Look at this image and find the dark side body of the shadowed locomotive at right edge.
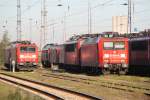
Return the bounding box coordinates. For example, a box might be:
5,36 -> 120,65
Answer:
130,39 -> 150,66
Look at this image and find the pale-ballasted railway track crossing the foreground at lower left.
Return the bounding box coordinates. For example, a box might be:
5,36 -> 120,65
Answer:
0,73 -> 101,100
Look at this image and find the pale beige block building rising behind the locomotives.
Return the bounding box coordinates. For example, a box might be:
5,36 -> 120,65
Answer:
112,16 -> 128,34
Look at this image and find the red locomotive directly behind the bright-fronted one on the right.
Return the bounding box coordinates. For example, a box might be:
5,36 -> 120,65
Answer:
61,34 -> 98,71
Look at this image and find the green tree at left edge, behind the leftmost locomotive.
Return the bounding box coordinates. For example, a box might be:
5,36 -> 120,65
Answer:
0,32 -> 10,64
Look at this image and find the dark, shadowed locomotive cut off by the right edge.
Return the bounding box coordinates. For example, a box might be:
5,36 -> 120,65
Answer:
129,30 -> 150,74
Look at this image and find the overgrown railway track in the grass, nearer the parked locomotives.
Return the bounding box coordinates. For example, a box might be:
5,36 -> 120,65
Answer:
42,73 -> 150,95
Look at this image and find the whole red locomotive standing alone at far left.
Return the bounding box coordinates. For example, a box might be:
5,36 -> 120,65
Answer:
4,41 -> 38,70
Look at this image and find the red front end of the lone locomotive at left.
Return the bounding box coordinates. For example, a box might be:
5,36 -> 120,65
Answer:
17,45 -> 38,70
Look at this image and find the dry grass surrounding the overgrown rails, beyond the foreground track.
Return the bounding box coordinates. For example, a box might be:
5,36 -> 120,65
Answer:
1,69 -> 150,100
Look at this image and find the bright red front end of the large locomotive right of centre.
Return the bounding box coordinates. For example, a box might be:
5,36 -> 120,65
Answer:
102,38 -> 128,74
